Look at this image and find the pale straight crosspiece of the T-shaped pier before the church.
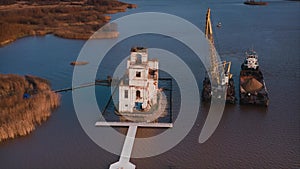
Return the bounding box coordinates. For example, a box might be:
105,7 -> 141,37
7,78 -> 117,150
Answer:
95,121 -> 173,128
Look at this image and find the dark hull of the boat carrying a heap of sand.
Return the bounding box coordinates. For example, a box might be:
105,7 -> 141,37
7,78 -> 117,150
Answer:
239,66 -> 269,106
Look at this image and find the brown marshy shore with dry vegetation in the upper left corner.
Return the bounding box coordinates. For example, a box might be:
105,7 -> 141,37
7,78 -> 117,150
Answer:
0,0 -> 137,47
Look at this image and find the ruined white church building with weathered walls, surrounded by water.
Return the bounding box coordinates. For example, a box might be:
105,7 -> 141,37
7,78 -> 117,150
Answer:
118,47 -> 159,113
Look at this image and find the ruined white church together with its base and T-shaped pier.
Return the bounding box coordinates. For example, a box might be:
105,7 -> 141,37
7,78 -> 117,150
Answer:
95,47 -> 169,169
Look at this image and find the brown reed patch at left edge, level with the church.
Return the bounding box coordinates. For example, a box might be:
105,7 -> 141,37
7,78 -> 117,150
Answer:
0,74 -> 60,142
